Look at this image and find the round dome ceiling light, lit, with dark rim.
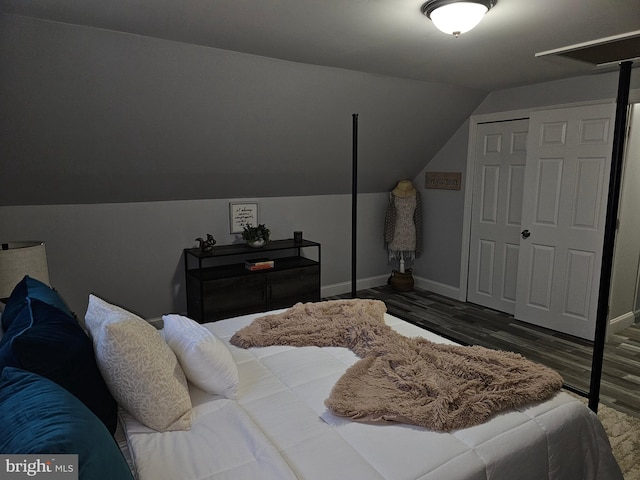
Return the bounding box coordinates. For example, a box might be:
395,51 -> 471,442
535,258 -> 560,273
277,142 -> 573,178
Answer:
420,0 -> 498,37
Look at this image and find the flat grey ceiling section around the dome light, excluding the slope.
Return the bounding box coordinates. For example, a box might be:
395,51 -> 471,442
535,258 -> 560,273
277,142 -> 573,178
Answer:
5,0 -> 640,91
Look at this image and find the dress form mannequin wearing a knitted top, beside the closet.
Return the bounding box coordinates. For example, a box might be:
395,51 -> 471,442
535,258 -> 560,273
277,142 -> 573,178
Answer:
384,180 -> 422,288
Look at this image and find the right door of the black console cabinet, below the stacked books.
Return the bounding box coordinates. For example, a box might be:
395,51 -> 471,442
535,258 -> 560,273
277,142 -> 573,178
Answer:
267,265 -> 320,310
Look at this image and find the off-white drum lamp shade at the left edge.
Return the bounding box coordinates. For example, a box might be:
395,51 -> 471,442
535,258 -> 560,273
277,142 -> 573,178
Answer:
0,242 -> 49,299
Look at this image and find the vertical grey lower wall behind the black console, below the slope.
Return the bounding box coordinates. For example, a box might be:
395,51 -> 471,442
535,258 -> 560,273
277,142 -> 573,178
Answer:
0,194 -> 390,317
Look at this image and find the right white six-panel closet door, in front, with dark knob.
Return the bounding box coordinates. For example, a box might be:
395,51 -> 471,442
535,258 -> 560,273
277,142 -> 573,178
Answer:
515,104 -> 615,340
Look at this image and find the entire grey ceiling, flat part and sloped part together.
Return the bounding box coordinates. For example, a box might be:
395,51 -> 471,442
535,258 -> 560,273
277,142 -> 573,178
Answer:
0,0 -> 640,205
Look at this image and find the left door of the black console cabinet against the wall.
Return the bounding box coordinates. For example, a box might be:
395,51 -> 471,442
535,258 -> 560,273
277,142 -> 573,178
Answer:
203,273 -> 266,322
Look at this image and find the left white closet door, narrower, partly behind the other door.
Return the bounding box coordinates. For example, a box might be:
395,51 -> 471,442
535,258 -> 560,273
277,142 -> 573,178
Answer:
467,119 -> 529,314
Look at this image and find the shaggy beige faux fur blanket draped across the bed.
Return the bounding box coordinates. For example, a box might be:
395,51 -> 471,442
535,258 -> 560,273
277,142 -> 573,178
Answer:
231,300 -> 562,431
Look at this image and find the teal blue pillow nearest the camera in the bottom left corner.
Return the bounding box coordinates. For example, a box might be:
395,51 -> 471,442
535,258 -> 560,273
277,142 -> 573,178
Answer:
0,367 -> 133,480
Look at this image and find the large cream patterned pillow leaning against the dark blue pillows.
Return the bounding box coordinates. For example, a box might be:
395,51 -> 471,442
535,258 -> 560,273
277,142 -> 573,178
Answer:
85,295 -> 191,432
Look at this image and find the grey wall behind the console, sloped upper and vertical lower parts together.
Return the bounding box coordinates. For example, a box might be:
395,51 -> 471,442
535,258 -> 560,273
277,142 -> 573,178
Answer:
0,15 -> 486,316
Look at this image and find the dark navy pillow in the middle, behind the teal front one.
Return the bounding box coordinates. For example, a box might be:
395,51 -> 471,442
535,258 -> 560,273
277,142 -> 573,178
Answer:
0,298 -> 118,433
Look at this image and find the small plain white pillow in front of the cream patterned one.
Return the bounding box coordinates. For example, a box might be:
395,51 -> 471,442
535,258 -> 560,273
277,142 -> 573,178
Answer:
162,315 -> 238,398
